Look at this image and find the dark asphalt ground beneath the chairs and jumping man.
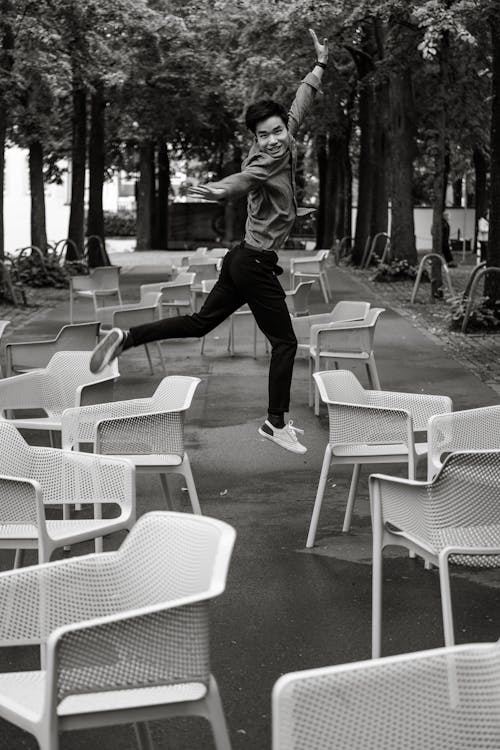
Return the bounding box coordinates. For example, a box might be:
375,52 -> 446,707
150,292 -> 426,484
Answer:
0,253 -> 500,750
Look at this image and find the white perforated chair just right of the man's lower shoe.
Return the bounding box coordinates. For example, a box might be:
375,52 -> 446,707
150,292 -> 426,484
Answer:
306,370 -> 452,547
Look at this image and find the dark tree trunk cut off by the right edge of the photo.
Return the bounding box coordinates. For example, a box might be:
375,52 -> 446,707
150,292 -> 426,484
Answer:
485,2 -> 500,304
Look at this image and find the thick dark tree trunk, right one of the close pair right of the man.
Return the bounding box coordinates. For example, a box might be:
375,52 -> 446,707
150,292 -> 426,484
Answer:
389,69 -> 417,265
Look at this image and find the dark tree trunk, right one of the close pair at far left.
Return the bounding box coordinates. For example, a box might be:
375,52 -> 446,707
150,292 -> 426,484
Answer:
87,82 -> 107,268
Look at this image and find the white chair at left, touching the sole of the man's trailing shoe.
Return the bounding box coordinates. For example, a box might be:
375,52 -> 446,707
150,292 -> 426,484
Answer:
5,321 -> 99,377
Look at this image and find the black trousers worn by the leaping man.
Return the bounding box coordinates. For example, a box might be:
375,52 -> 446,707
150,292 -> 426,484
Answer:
130,242 -> 297,413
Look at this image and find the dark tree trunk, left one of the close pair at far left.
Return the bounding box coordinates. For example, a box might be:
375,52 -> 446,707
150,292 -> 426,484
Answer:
67,85 -> 87,260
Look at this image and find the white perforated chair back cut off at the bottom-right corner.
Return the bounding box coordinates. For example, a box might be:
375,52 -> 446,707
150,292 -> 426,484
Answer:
272,643 -> 500,750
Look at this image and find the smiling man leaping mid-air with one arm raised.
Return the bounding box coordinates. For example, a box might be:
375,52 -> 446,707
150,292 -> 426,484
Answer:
90,29 -> 328,453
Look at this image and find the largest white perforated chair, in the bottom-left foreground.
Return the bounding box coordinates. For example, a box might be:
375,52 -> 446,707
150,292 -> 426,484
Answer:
0,512 -> 235,750
